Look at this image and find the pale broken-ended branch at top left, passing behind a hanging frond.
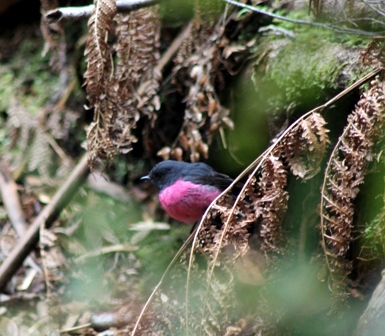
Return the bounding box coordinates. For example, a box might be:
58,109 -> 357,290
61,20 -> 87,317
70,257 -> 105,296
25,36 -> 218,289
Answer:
45,0 -> 159,23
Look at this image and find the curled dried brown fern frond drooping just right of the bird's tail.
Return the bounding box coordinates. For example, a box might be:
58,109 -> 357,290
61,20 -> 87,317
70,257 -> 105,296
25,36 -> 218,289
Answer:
197,113 -> 329,255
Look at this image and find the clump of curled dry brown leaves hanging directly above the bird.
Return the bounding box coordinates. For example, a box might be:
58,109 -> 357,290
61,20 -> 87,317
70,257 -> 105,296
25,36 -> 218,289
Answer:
158,0 -> 233,162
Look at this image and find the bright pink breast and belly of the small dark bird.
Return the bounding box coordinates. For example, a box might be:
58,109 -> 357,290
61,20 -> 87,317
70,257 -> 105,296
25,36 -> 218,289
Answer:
159,180 -> 221,224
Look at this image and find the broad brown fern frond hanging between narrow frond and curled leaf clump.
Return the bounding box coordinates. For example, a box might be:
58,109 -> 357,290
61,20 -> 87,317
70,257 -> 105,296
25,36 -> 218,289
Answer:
112,6 -> 161,153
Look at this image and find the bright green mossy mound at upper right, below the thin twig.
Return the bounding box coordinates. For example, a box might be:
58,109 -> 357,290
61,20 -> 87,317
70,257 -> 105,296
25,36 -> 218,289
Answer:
249,13 -> 370,111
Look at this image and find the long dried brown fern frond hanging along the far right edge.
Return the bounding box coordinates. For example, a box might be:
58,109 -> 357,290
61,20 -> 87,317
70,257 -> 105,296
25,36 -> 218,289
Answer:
321,79 -> 385,306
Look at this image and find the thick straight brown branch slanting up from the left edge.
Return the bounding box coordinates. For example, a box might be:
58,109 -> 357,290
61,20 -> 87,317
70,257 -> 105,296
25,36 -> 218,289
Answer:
0,155 -> 89,288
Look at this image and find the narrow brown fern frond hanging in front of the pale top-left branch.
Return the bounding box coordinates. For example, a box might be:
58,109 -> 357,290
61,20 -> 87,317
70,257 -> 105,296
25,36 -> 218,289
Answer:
84,0 -> 118,167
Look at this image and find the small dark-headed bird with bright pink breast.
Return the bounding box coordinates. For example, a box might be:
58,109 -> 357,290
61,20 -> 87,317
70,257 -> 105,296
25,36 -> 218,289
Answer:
141,160 -> 237,224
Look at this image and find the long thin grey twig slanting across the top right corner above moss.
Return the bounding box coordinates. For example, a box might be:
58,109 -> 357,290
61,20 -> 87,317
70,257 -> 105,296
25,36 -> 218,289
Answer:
224,0 -> 383,36
